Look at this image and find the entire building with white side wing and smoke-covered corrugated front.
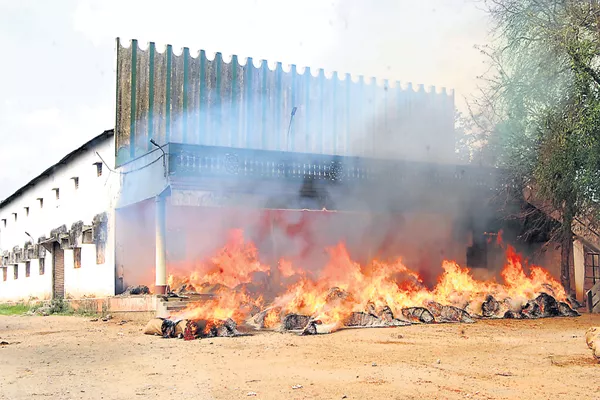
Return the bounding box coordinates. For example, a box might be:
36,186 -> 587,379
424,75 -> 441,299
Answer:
0,40 -> 596,306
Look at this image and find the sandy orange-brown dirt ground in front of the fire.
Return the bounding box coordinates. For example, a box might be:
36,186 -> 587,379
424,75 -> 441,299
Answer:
0,315 -> 600,399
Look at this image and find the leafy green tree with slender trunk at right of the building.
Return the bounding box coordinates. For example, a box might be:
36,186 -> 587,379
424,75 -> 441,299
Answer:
471,0 -> 600,290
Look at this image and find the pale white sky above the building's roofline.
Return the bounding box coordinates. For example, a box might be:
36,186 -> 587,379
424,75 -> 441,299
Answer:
0,0 -> 489,199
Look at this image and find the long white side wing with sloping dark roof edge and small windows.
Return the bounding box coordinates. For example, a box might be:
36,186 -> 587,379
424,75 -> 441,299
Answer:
0,130 -> 120,301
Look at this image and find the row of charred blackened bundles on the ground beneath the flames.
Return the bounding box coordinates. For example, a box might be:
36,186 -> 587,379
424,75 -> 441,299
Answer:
144,288 -> 580,340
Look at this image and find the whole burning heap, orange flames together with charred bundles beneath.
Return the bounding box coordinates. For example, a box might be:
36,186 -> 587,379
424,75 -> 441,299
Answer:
142,231 -> 579,340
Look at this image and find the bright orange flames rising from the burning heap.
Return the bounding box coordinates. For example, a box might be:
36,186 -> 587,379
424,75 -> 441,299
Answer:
169,230 -> 566,327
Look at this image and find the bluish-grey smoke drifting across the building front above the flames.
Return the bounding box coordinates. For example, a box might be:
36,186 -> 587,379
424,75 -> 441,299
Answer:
113,2 -> 556,286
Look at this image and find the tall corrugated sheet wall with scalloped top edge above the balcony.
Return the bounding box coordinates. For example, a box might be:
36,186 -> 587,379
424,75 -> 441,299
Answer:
115,39 -> 454,165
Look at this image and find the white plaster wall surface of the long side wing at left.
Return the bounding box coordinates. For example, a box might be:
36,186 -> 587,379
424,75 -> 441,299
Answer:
0,137 -> 121,300
